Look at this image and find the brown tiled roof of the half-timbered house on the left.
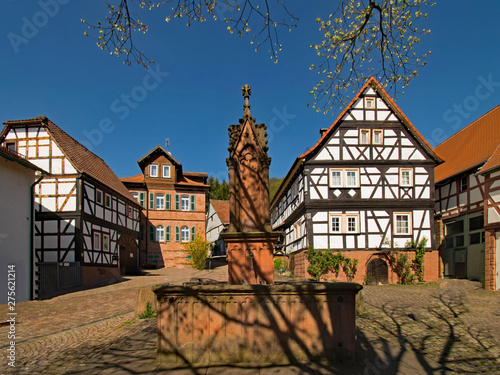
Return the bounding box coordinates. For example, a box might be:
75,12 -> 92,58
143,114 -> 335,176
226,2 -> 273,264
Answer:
0,116 -> 137,203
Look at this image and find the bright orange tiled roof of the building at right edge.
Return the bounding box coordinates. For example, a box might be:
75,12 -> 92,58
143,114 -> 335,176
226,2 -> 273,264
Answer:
435,105 -> 500,183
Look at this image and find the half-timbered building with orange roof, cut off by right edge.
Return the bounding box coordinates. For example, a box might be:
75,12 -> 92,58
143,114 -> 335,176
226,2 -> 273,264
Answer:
435,106 -> 500,290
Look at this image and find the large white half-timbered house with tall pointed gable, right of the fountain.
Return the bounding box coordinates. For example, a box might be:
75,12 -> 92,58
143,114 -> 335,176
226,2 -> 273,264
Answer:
271,78 -> 442,282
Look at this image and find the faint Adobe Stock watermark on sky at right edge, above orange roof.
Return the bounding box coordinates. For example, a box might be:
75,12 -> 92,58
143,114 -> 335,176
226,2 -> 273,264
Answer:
431,74 -> 500,144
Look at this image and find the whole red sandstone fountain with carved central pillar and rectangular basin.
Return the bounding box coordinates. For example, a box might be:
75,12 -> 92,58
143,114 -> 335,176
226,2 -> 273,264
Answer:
153,85 -> 362,368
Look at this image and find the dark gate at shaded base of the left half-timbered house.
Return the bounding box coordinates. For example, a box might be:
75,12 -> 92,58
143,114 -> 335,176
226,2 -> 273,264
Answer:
37,262 -> 80,294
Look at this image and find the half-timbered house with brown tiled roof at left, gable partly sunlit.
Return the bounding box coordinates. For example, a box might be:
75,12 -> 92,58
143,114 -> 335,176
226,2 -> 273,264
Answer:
0,116 -> 140,294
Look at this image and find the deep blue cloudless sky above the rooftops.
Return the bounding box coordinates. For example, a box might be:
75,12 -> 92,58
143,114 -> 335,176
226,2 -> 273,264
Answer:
0,0 -> 500,178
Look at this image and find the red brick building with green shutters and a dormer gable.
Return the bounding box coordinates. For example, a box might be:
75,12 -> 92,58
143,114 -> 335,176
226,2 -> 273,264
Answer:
121,146 -> 209,267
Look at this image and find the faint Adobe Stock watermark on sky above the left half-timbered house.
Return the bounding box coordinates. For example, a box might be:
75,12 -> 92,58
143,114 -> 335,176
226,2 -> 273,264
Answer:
80,64 -> 170,151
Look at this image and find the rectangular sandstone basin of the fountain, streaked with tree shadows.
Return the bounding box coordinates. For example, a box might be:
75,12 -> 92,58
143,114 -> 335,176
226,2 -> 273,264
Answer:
153,282 -> 362,368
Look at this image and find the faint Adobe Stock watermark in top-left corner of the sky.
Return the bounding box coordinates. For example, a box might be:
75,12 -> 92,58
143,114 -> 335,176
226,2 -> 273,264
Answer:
7,0 -> 70,53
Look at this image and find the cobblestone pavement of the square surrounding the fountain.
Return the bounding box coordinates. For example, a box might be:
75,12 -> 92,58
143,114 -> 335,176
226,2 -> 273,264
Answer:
0,266 -> 500,375
